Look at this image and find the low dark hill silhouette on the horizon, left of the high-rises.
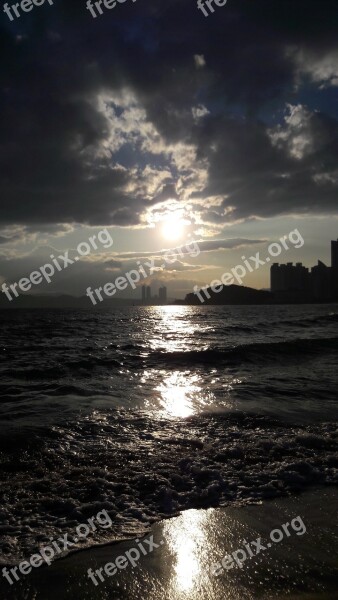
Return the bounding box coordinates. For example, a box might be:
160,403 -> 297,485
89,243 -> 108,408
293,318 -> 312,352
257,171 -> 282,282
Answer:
184,285 -> 273,305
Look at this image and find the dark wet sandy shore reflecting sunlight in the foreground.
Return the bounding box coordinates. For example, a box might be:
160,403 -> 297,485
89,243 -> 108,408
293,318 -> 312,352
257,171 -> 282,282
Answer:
0,488 -> 338,600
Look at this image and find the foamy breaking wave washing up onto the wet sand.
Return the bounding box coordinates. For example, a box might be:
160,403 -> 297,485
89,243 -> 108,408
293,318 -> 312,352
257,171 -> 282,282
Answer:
0,411 -> 338,564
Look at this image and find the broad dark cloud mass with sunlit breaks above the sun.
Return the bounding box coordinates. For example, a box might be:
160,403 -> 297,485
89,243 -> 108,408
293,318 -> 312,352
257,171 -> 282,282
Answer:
0,0 -> 338,237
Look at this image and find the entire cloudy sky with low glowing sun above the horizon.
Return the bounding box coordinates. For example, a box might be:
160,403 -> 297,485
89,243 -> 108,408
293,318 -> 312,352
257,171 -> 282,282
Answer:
0,0 -> 338,298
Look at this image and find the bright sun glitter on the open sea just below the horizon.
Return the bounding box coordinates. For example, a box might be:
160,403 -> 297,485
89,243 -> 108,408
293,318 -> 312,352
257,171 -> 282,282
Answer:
140,305 -> 238,418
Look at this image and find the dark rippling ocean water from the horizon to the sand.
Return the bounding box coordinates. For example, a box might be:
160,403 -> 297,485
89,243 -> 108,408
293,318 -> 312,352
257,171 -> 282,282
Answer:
0,305 -> 338,564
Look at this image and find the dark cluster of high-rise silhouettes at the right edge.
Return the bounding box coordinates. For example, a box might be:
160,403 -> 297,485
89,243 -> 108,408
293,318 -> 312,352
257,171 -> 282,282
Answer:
270,240 -> 338,302
